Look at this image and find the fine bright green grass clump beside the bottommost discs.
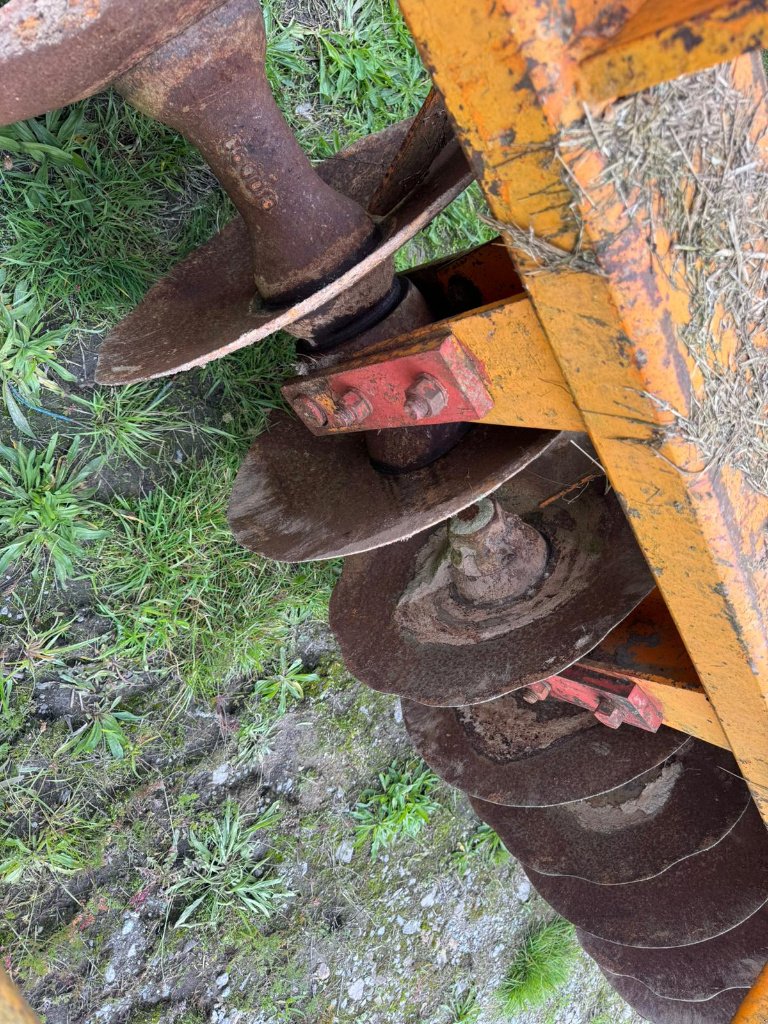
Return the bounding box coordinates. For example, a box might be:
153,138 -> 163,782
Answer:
498,918 -> 578,1015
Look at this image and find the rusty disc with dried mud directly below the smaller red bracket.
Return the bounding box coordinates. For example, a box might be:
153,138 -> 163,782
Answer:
402,693 -> 690,807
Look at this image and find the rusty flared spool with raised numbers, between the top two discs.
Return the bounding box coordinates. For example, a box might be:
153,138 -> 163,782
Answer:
115,0 -> 385,315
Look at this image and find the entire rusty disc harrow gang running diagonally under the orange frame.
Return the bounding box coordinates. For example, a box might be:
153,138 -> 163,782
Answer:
0,0 -> 768,1024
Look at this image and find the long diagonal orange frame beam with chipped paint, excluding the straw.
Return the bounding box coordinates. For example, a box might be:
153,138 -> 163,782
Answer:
400,0 -> 768,819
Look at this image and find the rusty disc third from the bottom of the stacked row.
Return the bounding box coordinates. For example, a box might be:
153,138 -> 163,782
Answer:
526,803 -> 768,948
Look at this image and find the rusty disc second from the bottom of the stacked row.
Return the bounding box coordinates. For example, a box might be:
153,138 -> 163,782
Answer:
579,904 -> 768,999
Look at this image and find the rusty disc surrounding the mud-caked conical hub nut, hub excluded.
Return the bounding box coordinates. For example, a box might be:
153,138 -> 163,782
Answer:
331,444 -> 653,707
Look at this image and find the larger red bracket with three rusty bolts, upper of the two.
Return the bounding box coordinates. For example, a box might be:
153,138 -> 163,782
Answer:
283,334 -> 494,434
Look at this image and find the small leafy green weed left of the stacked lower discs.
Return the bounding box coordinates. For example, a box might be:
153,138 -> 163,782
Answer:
351,759 -> 441,860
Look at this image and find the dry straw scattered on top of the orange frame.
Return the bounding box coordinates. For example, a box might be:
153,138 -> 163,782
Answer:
557,66 -> 768,495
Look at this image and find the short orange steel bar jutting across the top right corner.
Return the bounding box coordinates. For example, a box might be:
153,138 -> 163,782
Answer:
580,0 -> 768,100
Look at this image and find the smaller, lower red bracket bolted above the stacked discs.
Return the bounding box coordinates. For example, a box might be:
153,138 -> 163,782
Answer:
522,665 -> 664,732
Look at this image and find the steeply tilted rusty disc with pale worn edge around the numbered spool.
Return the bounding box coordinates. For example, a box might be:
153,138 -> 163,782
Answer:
95,129 -> 473,384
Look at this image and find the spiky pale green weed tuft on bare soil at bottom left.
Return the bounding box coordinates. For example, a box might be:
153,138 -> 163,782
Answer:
167,801 -> 292,928
